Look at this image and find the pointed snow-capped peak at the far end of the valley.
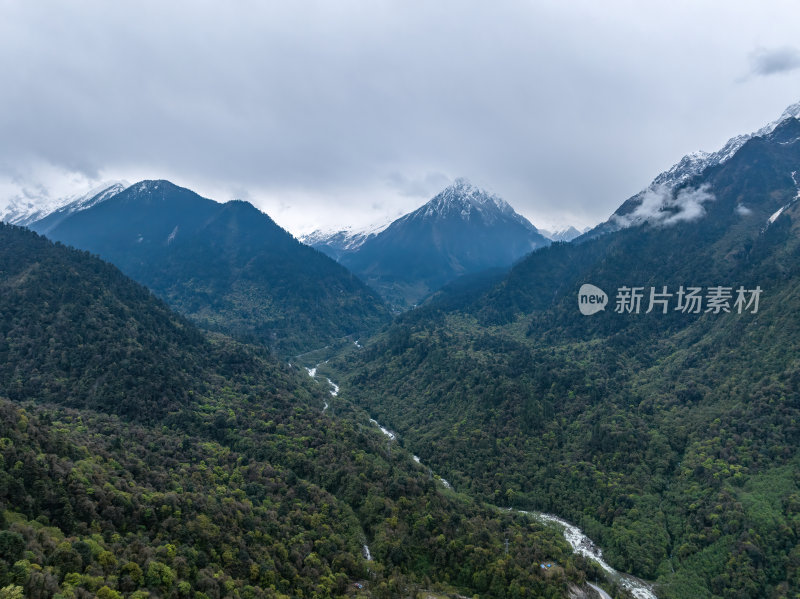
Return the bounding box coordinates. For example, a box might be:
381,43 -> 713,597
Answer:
316,179 -> 550,309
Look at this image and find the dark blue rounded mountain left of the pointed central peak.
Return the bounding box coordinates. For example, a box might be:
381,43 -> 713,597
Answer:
31,181 -> 388,354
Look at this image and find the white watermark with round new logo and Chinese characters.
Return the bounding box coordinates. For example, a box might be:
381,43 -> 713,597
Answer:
578,283 -> 762,316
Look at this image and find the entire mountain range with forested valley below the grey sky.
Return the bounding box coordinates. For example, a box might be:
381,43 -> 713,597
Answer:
0,104 -> 800,599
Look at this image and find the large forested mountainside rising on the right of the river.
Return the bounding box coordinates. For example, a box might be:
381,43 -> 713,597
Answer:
326,118 -> 800,598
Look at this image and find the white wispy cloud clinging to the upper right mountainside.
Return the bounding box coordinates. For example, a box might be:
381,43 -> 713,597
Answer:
613,185 -> 715,227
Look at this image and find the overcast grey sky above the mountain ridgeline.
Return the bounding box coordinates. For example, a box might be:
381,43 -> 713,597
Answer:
0,0 -> 800,234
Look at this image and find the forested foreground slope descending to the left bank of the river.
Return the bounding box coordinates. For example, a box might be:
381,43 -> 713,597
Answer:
0,225 -> 608,599
